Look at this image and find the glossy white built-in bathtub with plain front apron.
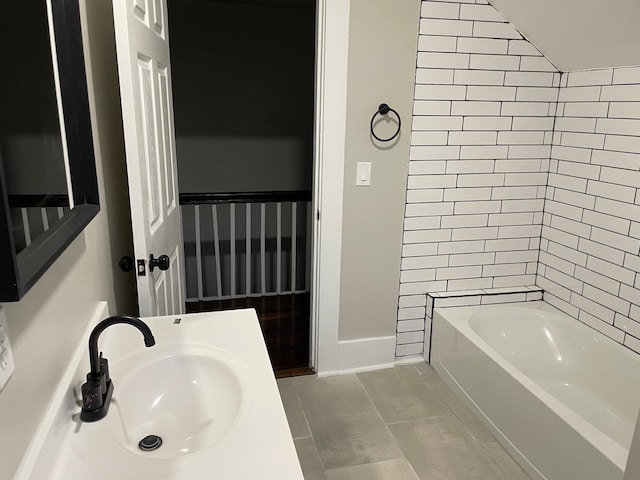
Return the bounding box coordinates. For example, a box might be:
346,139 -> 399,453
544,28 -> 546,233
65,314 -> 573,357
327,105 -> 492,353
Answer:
431,301 -> 640,480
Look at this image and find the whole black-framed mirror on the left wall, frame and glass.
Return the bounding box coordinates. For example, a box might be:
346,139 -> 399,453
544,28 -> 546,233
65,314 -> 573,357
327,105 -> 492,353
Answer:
0,0 -> 100,302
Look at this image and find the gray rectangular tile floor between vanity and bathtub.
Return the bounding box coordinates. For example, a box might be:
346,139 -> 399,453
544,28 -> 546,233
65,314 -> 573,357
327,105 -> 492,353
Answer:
278,363 -> 529,480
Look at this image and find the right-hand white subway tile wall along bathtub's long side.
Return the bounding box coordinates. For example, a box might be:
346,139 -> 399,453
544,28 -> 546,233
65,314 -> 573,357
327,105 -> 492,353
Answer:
537,67 -> 640,353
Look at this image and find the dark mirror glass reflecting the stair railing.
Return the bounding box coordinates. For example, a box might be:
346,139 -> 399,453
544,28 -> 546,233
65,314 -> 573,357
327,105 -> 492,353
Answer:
0,0 -> 69,253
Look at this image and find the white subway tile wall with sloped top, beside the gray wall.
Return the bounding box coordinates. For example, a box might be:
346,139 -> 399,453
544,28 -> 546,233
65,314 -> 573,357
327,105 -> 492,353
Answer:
396,0 -> 560,356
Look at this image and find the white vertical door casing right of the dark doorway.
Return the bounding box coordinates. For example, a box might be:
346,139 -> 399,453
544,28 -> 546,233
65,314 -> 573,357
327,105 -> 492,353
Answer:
310,0 -> 350,376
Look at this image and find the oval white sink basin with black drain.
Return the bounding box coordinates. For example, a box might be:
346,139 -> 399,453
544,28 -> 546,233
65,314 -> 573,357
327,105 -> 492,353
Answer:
108,347 -> 248,459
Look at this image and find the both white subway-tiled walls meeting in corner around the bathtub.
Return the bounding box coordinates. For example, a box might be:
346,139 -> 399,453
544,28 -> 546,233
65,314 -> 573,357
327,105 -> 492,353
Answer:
396,0 -> 640,357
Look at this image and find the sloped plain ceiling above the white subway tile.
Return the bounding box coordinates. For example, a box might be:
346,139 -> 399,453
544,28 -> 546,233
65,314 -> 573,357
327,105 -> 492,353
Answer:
489,0 -> 640,72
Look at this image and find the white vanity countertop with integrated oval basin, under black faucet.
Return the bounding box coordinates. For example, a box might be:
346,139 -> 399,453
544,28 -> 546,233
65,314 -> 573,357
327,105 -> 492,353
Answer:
18,310 -> 303,480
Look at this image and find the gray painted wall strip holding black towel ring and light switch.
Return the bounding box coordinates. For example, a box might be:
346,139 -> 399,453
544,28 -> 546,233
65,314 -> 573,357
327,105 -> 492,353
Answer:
339,0 -> 420,340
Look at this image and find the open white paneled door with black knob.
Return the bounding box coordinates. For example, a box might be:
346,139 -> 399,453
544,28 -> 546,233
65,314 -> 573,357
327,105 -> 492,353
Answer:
113,0 -> 185,316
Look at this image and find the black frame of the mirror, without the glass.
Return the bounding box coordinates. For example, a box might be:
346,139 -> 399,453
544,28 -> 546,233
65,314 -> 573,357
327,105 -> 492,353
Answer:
0,0 -> 100,302
